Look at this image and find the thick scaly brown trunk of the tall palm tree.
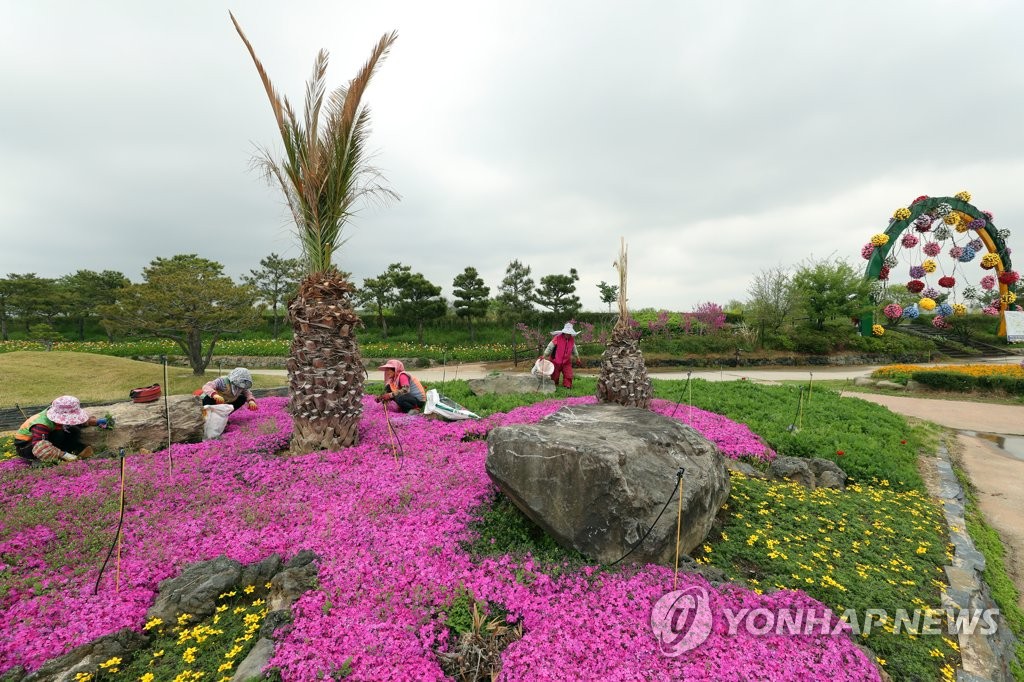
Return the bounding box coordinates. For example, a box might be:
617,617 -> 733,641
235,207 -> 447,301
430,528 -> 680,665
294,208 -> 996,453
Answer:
288,271 -> 366,455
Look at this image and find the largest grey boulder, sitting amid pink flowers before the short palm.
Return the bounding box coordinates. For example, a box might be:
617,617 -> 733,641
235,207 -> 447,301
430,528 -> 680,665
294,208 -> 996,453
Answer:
486,403 -> 729,563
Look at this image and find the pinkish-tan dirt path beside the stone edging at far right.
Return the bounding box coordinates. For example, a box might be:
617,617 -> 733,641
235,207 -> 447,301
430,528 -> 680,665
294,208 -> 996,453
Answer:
844,393 -> 1024,608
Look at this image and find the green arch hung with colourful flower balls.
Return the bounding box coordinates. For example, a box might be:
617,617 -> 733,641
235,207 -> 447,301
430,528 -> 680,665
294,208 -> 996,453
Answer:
859,191 -> 1020,336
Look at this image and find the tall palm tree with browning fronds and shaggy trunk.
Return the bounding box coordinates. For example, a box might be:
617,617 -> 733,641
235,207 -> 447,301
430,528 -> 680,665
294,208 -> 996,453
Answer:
231,14 -> 397,454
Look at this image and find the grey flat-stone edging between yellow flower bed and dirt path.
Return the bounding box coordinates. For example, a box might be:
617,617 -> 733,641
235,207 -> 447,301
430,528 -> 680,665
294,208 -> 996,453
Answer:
935,443 -> 1017,682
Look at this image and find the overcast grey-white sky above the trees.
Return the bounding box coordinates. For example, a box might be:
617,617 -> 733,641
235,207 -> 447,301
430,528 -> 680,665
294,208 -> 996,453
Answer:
0,0 -> 1024,310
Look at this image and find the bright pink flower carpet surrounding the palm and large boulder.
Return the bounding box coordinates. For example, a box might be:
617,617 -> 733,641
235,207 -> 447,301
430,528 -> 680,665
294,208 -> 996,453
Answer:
0,398 -> 879,681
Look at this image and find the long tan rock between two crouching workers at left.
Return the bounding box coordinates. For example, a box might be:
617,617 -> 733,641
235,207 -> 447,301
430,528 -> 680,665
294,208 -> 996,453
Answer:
82,395 -> 203,453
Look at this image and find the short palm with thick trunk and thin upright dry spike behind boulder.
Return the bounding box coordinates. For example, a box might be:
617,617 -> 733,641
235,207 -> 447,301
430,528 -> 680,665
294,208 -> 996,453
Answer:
597,239 -> 654,410
